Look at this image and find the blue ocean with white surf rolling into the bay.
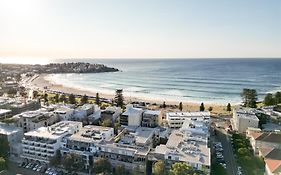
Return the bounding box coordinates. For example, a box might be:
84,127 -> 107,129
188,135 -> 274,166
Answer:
44,58 -> 281,104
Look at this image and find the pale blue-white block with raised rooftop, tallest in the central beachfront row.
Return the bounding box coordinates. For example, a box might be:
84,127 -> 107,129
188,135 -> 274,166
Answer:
120,104 -> 143,126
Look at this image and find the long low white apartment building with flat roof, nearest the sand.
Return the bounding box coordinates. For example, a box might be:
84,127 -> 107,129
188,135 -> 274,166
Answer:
166,111 -> 210,128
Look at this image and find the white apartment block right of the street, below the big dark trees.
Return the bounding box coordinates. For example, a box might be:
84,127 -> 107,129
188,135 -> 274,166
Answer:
232,107 -> 259,133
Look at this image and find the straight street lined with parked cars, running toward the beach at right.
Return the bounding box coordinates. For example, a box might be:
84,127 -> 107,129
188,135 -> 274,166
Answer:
216,129 -> 238,175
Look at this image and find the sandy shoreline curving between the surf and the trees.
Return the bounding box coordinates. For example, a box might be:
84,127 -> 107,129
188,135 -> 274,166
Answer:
26,74 -> 237,113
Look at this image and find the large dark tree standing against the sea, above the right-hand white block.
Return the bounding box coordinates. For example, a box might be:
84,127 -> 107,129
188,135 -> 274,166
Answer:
241,88 -> 258,108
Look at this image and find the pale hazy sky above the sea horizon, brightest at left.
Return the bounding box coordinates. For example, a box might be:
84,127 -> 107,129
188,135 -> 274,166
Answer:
0,0 -> 281,58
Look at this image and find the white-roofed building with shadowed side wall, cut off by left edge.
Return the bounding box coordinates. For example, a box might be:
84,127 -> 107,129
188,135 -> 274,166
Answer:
0,122 -> 23,159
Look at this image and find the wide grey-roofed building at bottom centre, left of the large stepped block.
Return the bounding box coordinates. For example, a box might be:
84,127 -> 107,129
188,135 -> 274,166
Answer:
97,127 -> 159,173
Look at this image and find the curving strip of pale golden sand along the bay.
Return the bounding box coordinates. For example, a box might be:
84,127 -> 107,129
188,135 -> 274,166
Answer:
26,74 -> 231,115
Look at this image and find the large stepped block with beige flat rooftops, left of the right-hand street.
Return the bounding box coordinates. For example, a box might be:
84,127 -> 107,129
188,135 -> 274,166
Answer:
149,116 -> 211,174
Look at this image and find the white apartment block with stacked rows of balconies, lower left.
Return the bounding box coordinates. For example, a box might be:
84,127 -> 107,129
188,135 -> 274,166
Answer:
21,121 -> 82,163
